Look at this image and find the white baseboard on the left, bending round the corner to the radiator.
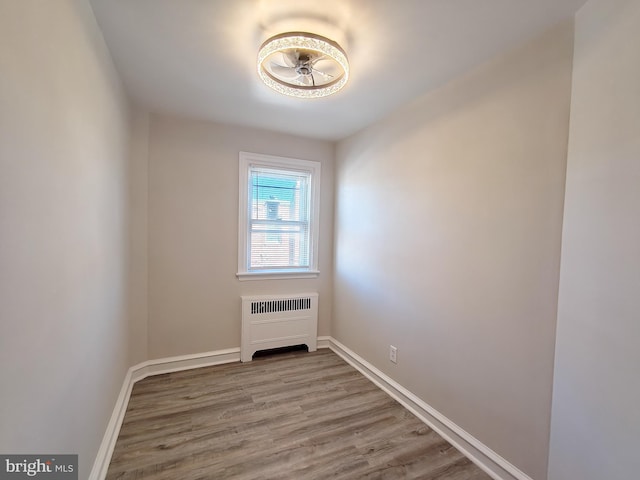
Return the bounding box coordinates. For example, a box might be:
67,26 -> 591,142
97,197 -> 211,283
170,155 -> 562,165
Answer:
89,348 -> 240,480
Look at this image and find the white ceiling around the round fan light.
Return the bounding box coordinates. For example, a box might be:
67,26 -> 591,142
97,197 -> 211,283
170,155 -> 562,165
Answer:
91,0 -> 585,140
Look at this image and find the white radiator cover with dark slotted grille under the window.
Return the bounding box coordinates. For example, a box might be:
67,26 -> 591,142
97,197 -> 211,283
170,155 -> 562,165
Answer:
240,293 -> 318,362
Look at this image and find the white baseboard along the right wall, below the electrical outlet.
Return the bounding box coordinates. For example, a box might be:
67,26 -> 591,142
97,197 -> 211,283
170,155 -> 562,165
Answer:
318,337 -> 532,480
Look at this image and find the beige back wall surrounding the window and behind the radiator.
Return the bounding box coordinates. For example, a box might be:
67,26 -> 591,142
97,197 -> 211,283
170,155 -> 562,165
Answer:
148,115 -> 334,358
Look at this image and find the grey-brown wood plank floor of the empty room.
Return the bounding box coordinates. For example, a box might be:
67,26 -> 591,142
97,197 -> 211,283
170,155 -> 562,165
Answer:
107,350 -> 490,480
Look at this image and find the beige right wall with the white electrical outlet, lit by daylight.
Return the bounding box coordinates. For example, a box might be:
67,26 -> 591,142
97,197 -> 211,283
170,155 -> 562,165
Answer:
332,25 -> 573,479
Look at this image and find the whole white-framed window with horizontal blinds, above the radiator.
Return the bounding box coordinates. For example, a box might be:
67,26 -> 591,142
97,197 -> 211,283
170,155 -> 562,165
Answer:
238,152 -> 320,280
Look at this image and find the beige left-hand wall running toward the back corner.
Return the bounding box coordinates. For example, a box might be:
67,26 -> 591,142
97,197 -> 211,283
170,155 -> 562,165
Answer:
0,0 -> 129,478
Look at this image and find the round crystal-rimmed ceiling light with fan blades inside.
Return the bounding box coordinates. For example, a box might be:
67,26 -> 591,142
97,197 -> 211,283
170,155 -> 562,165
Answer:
258,32 -> 349,98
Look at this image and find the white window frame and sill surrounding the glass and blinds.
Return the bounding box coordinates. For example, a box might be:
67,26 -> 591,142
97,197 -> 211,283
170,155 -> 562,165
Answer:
236,152 -> 321,280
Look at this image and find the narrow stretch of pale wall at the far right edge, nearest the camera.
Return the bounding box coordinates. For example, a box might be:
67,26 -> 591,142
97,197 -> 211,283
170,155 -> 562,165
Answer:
549,0 -> 640,480
